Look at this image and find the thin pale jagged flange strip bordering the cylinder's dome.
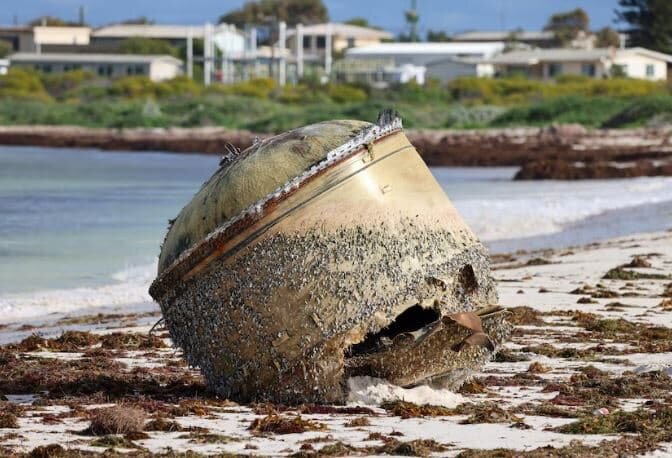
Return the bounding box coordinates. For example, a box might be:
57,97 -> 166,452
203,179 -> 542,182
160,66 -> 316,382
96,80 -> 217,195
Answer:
155,110 -> 403,281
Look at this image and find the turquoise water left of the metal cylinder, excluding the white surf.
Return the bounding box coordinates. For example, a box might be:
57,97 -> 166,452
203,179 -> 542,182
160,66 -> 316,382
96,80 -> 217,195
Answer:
0,147 -> 217,294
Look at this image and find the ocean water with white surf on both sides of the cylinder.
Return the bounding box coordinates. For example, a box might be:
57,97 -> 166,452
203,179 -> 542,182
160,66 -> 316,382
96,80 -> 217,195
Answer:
0,146 -> 672,321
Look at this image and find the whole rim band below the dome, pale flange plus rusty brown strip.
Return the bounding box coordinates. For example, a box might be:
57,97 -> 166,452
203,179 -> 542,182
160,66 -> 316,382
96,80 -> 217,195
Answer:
149,110 -> 404,300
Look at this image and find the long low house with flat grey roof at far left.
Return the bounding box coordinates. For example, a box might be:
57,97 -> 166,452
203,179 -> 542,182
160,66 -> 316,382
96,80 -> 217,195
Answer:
9,53 -> 182,81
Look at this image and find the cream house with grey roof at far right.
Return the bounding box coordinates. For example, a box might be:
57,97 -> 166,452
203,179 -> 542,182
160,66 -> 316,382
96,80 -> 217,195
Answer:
483,48 -> 672,81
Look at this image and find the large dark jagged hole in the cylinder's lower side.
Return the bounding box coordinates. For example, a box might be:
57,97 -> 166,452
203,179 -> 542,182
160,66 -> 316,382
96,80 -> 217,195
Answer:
345,305 -> 441,358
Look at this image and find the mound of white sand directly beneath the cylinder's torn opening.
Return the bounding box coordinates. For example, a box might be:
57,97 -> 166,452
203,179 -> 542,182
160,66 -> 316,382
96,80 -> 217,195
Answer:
348,376 -> 467,408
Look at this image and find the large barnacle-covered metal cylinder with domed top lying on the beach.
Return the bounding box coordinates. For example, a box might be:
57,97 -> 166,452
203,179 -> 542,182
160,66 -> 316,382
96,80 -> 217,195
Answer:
150,112 -> 509,403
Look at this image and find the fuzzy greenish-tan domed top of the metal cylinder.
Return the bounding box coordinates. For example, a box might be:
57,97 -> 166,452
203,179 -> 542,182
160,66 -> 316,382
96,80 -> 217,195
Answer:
159,120 -> 372,274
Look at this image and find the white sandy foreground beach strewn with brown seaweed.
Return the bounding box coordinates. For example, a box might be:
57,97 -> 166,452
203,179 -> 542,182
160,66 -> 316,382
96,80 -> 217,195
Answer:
0,231 -> 672,457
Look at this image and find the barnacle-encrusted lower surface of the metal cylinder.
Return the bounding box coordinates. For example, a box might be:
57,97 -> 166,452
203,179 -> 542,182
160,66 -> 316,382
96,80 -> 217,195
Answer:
163,220 -> 506,403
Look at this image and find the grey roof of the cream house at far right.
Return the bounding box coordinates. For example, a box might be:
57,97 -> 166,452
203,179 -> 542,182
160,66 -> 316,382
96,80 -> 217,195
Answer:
487,48 -> 615,65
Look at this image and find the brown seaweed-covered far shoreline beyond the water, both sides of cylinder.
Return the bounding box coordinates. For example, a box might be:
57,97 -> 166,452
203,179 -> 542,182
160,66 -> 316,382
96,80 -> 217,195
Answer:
0,125 -> 672,172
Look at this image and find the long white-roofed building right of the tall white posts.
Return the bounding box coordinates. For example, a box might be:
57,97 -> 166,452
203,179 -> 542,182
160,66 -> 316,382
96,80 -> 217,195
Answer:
345,42 -> 504,82
